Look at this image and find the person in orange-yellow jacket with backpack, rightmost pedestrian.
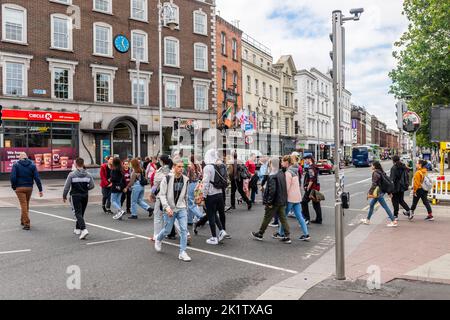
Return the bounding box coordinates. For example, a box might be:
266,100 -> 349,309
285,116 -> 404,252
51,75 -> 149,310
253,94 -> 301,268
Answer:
409,160 -> 434,221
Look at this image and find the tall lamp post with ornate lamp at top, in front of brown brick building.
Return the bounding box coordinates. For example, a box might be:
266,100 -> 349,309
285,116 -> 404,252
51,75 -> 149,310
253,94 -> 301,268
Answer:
158,0 -> 178,154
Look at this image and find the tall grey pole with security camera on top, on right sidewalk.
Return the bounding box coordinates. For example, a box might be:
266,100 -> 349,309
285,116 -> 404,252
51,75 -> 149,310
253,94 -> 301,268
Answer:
330,8 -> 364,280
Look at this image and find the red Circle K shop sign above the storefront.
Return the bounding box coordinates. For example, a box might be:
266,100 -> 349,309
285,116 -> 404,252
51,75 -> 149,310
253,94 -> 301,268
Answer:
2,110 -> 80,122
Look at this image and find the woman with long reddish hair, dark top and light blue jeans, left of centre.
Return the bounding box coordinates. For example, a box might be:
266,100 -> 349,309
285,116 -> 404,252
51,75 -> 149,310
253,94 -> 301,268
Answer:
123,159 -> 153,219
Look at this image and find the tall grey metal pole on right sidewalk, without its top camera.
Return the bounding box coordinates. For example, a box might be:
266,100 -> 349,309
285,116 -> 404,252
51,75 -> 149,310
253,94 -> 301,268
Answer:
333,10 -> 345,280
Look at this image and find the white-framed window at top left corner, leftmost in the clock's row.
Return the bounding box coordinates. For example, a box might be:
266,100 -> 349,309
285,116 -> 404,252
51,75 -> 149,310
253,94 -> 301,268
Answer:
2,3 -> 27,44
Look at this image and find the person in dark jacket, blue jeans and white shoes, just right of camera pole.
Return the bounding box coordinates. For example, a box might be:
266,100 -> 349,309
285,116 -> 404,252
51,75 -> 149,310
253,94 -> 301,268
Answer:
361,161 -> 398,227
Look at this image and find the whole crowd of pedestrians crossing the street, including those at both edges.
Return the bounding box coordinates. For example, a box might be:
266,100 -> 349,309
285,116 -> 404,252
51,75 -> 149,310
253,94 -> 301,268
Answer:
7,149 -> 434,261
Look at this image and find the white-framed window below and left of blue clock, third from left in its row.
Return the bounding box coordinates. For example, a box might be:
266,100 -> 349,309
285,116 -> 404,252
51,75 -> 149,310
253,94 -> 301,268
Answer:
91,64 -> 116,103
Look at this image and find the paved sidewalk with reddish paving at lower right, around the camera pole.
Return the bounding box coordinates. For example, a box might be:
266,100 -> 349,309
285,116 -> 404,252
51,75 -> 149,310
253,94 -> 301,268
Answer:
259,199 -> 450,300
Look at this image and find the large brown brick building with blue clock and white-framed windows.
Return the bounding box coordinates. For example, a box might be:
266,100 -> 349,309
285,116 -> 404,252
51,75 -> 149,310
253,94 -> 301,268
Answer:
0,0 -> 216,172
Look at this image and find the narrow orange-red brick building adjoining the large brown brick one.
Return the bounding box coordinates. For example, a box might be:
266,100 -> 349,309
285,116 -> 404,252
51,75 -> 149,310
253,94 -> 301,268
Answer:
216,16 -> 243,128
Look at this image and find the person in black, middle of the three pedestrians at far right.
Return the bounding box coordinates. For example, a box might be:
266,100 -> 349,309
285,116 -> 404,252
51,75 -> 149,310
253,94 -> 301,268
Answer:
391,156 -> 411,220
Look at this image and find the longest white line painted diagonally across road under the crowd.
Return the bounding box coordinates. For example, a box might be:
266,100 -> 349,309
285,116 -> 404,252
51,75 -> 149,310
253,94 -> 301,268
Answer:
30,210 -> 298,274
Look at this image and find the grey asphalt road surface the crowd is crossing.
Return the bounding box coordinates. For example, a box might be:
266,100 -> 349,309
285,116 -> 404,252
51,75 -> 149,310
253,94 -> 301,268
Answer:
0,162 -> 390,300
